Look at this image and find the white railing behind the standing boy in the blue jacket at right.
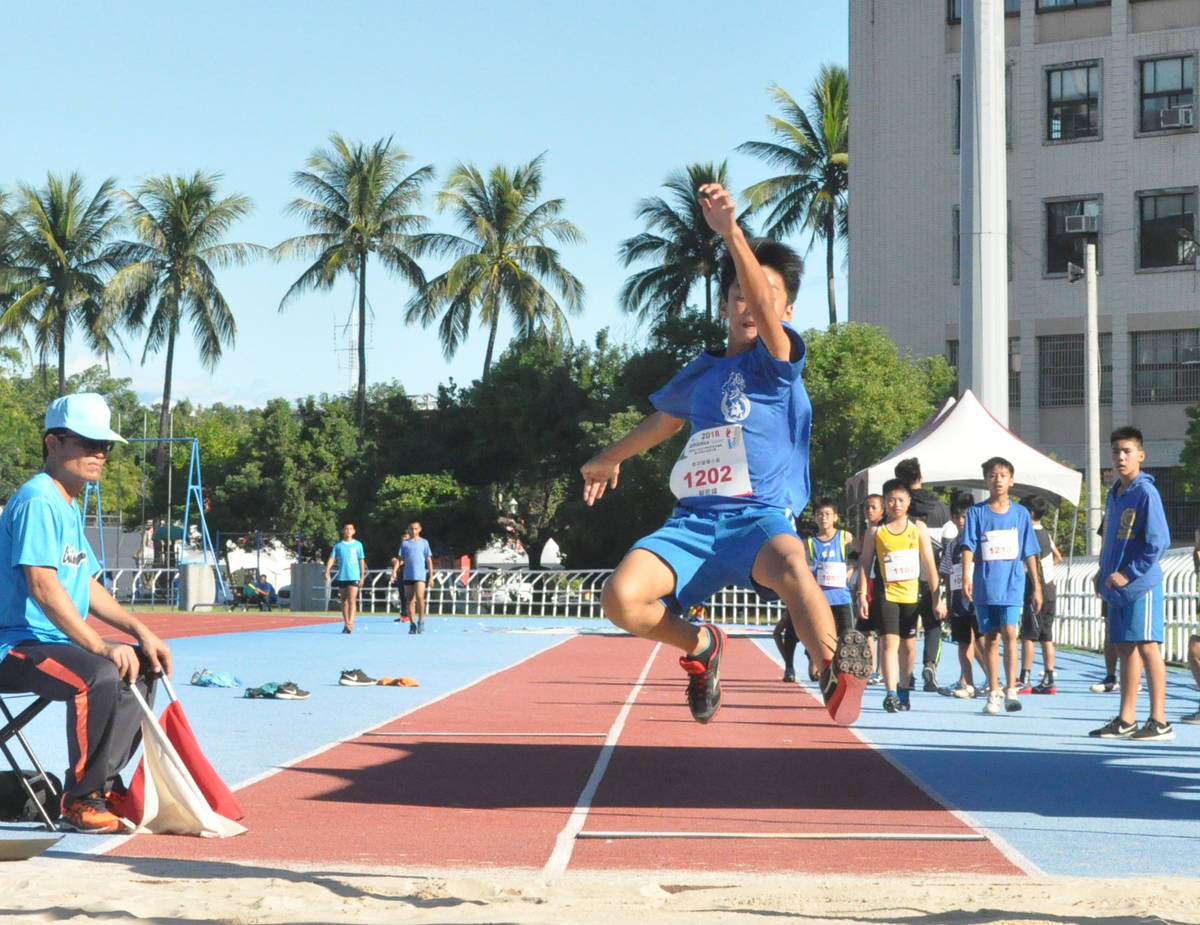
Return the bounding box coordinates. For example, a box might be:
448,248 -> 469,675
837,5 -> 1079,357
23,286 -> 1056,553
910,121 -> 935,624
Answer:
1054,547 -> 1200,663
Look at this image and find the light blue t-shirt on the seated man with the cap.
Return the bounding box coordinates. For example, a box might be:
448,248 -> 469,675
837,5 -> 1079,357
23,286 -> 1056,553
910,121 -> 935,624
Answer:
0,473 -> 100,659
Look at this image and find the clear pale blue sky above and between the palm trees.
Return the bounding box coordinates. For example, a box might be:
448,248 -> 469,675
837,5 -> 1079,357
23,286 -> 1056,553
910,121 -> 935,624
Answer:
0,0 -> 847,406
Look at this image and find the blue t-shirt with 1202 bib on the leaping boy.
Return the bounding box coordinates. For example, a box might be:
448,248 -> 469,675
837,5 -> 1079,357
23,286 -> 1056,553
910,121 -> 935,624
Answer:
650,324 -> 812,512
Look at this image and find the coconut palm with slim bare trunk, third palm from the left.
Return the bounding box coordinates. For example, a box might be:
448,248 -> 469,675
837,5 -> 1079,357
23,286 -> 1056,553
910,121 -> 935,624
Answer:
271,132 -> 433,427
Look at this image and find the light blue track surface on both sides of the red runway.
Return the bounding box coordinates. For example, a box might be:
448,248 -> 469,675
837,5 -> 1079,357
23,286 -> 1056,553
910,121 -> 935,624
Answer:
0,617 -> 1200,877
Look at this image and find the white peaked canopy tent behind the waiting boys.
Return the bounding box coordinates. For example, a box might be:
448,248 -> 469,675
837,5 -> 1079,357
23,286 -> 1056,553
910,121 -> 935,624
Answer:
846,389 -> 1084,505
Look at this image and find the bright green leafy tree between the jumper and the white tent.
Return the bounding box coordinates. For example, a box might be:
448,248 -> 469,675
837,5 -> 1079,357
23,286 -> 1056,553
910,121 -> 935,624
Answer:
804,324 -> 954,511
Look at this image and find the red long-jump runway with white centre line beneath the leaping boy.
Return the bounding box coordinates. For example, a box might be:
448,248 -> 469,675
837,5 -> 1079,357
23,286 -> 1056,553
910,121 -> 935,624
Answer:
113,636 -> 1022,876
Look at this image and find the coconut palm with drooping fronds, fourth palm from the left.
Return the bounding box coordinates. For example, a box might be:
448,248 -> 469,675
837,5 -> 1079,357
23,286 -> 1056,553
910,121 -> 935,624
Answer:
407,155 -> 583,379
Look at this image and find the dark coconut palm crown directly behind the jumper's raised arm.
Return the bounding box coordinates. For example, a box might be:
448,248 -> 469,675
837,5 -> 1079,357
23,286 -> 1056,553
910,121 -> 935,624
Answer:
617,161 -> 746,320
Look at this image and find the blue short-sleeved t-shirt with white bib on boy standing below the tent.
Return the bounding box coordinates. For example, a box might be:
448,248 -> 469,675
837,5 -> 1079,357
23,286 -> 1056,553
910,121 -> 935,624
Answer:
962,501 -> 1042,607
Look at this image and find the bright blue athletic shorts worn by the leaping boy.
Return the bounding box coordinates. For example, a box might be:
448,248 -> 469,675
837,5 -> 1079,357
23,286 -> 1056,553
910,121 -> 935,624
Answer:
632,507 -> 798,614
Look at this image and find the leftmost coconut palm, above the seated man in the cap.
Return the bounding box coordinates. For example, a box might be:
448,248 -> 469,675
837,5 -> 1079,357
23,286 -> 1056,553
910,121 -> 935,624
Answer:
0,173 -> 121,395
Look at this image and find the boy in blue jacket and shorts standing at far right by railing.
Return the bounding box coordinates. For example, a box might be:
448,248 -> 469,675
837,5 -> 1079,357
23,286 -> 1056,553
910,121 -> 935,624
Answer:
1090,427 -> 1175,741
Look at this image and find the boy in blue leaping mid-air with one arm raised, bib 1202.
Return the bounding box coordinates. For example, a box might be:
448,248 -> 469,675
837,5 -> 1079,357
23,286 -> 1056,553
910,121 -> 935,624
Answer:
581,184 -> 870,723
